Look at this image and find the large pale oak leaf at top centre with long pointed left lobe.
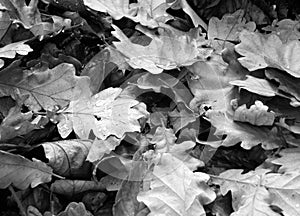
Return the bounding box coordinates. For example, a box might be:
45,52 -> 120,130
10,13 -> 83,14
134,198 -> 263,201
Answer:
112,25 -> 209,74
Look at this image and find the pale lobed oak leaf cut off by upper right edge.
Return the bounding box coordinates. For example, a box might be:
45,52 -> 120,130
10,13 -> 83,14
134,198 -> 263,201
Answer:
235,31 -> 300,78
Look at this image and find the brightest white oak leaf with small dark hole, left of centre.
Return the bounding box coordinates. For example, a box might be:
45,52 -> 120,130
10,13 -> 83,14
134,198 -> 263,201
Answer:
58,88 -> 148,140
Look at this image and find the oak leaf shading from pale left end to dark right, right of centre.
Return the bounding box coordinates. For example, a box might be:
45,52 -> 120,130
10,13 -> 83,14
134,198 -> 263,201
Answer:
207,111 -> 282,149
